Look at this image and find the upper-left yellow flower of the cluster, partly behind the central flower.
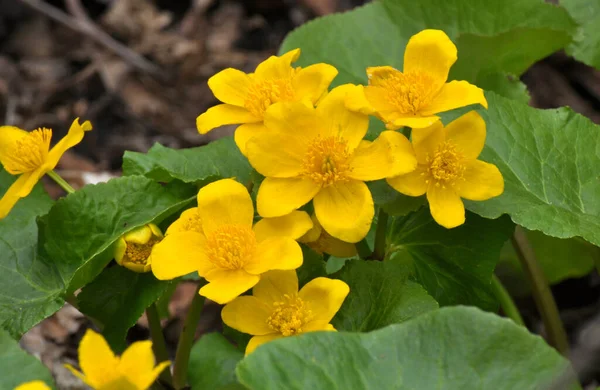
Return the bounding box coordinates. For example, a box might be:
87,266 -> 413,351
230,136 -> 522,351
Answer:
196,49 -> 337,155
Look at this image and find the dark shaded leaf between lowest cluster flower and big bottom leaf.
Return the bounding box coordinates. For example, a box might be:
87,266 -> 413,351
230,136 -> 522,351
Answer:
330,260 -> 438,332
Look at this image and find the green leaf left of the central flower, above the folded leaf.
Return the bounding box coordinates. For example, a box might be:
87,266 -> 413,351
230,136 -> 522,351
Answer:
123,137 -> 252,185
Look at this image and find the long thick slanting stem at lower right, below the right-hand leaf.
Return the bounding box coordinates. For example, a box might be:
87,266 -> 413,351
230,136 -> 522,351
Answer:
512,226 -> 569,356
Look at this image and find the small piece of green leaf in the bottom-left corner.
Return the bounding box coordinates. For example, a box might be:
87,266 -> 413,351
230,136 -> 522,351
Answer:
0,330 -> 54,390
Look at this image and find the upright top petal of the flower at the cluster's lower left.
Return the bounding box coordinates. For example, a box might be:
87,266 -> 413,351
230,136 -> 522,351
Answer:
198,179 -> 254,236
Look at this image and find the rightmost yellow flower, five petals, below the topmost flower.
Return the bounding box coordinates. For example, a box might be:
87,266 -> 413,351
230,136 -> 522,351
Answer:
387,111 -> 504,228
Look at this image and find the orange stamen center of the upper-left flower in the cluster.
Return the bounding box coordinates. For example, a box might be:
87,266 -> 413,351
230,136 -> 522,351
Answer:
244,78 -> 295,118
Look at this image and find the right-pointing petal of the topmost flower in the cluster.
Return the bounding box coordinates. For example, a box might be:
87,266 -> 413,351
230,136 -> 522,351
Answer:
420,81 -> 487,115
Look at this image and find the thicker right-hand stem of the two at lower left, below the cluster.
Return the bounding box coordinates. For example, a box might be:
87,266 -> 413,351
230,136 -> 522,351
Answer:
173,286 -> 204,390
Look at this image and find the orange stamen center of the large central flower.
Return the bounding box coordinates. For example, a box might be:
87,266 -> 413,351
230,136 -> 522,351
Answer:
302,137 -> 351,187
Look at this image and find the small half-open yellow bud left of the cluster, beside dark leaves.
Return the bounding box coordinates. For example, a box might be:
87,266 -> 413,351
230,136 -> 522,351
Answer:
115,223 -> 163,272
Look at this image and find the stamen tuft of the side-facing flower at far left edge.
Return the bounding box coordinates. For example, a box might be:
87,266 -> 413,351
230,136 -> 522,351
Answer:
3,128 -> 52,175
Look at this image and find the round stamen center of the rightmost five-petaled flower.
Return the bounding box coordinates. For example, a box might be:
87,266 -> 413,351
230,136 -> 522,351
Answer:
427,141 -> 466,186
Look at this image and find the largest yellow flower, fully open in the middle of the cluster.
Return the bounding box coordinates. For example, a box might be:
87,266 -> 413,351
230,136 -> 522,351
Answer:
247,85 -> 417,243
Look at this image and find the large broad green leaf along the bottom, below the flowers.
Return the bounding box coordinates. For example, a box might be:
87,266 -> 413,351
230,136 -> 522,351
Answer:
236,307 -> 577,390
